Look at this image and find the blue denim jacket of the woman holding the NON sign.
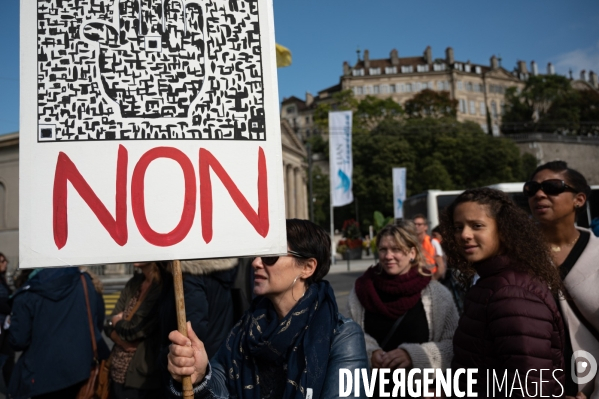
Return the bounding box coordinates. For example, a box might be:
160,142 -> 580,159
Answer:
170,314 -> 370,399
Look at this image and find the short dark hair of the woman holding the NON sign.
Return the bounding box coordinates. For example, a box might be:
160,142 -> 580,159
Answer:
287,219 -> 331,286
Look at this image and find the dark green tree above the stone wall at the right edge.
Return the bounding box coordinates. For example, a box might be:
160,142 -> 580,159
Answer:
502,75 -> 599,135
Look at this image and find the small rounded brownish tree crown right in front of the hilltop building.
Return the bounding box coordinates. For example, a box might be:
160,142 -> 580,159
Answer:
405,89 -> 458,118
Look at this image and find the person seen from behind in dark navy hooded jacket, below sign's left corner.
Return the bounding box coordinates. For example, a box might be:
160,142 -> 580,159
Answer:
8,267 -> 108,399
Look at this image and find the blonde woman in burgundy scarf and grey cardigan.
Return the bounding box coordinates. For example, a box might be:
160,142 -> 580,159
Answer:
348,222 -> 458,382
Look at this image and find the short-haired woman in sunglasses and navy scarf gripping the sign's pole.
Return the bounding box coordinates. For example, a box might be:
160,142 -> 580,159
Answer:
168,219 -> 368,399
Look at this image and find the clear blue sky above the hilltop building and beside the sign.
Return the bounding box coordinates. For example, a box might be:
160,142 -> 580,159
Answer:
0,0 -> 599,134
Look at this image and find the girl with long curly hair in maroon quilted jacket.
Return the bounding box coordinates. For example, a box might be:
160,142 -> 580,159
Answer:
441,188 -> 565,397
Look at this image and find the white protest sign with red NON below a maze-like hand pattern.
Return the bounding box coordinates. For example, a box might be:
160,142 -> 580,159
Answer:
19,0 -> 287,268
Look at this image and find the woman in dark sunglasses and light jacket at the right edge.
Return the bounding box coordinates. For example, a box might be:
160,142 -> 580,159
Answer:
524,161 -> 599,398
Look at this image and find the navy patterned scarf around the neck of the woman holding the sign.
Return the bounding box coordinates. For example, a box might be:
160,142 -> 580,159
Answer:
225,281 -> 338,399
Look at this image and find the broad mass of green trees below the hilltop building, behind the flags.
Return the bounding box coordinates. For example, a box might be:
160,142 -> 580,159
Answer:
313,89 -> 536,233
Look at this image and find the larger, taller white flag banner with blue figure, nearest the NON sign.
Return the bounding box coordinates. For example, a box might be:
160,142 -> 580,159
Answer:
329,111 -> 354,206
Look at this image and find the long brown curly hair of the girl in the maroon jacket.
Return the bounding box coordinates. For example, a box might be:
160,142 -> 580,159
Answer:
441,188 -> 562,294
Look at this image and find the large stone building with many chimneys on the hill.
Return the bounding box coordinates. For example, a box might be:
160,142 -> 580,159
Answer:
281,46 -> 599,140
